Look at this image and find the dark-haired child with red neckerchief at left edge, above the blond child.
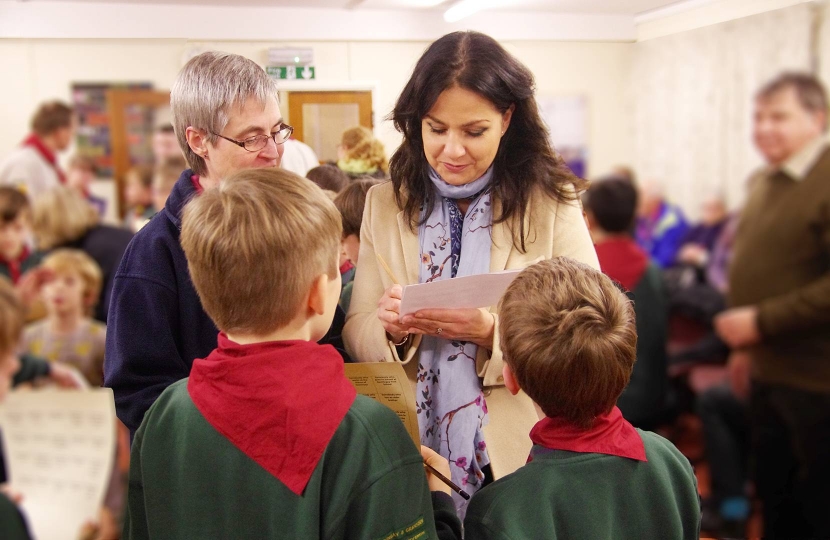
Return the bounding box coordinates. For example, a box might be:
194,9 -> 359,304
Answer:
0,186 -> 43,284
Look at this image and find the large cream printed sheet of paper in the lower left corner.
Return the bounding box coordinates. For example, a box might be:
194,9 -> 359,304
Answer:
0,388 -> 115,540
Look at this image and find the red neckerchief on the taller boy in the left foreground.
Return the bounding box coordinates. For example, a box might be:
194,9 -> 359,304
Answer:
187,333 -> 357,495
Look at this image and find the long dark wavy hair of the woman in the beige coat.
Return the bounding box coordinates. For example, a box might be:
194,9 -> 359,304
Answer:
389,32 -> 586,252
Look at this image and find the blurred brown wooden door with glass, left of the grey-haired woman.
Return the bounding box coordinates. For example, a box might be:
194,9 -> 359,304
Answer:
107,89 -> 170,219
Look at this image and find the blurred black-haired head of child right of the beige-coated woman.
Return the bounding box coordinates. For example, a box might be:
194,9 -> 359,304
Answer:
582,176 -> 637,234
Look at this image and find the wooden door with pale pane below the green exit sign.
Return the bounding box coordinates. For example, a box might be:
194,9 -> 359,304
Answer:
287,91 -> 373,162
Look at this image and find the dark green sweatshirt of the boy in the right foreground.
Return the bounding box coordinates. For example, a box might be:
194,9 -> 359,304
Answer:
464,430 -> 700,540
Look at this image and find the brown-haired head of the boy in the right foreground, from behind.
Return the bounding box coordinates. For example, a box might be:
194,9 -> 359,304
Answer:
499,257 -> 637,428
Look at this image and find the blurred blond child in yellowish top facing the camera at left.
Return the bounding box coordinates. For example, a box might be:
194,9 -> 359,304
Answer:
22,249 -> 107,387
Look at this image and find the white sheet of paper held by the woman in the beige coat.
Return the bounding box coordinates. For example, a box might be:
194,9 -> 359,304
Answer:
401,270 -> 521,317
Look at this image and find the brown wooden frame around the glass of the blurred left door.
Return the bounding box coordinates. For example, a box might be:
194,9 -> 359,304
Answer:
106,88 -> 170,219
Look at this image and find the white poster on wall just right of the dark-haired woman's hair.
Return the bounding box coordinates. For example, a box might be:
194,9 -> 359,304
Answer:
537,96 -> 588,178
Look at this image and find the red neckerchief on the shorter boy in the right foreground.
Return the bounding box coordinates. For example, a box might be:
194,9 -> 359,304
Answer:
530,407 -> 648,461
